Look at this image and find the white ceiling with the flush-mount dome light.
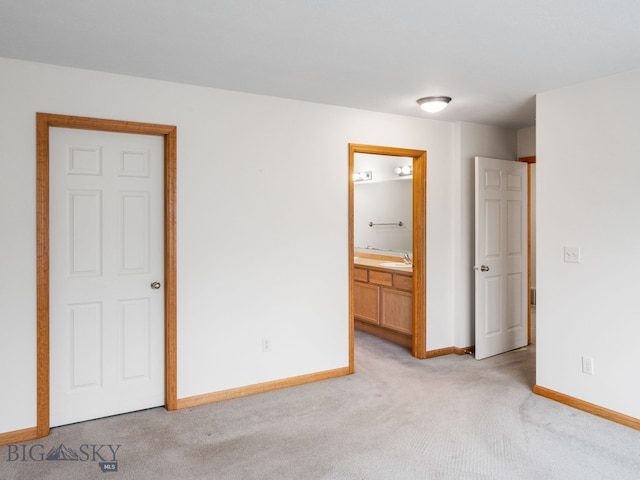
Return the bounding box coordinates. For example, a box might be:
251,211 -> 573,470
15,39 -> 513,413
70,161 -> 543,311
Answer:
0,0 -> 640,128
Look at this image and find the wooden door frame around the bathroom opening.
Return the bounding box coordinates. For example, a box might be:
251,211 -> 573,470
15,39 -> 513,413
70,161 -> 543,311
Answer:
349,143 -> 427,373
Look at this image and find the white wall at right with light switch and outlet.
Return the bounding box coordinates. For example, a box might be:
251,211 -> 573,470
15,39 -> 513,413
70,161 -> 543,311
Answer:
536,70 -> 640,418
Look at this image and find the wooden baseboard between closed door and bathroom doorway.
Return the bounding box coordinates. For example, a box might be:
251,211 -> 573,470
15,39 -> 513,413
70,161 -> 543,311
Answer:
177,367 -> 352,409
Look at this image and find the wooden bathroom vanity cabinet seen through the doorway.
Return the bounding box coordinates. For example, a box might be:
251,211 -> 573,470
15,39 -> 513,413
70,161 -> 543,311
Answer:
353,262 -> 413,347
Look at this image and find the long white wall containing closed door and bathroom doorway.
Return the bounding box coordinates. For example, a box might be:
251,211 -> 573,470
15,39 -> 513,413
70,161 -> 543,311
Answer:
0,59 -> 458,433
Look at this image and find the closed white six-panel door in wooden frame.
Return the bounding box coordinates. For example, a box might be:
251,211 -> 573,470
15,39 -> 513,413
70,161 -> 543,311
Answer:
49,128 -> 164,426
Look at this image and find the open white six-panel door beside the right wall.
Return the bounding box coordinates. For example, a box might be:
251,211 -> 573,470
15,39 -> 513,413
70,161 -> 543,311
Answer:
474,157 -> 528,360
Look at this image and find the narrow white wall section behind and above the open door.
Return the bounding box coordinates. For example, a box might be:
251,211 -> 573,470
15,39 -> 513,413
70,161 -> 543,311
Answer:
450,122 -> 517,347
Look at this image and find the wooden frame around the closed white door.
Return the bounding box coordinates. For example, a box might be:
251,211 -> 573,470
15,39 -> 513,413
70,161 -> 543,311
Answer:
36,113 -> 178,438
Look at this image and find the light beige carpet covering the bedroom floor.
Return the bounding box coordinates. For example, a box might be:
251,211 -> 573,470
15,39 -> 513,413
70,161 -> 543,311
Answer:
0,332 -> 640,480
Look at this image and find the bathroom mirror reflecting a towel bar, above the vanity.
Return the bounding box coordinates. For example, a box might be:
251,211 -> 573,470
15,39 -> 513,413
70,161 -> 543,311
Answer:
353,153 -> 413,256
